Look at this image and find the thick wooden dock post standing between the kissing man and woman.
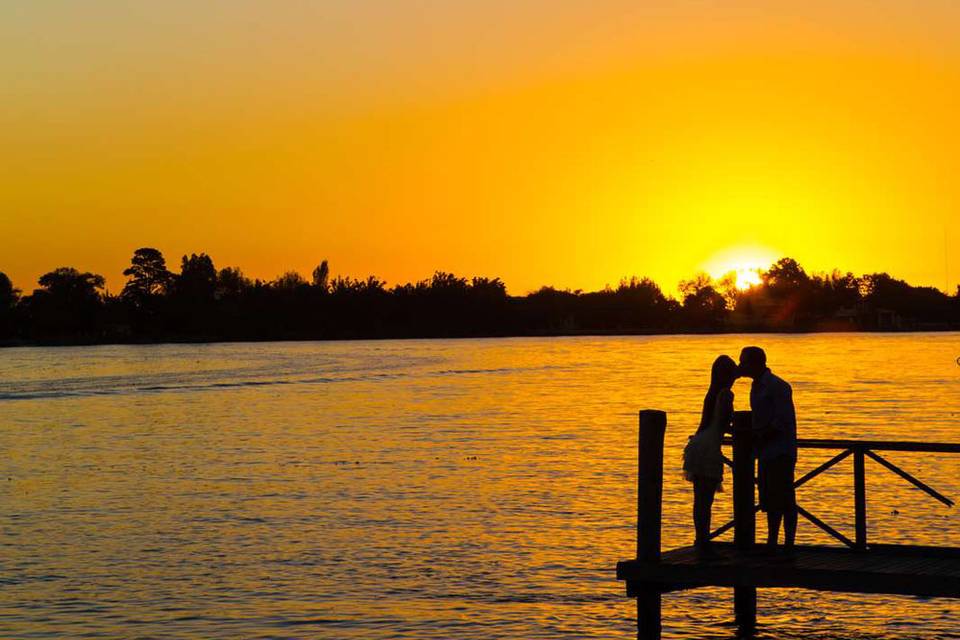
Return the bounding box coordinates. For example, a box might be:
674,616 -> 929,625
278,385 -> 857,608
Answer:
733,411 -> 757,636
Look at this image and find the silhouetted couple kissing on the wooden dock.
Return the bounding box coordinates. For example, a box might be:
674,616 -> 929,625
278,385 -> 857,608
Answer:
683,347 -> 797,557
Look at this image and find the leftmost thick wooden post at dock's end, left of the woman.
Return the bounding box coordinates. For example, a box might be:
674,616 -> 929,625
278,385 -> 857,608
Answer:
636,409 -> 667,640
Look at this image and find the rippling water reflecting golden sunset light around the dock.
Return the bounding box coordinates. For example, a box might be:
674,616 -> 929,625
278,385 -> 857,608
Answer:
0,333 -> 960,640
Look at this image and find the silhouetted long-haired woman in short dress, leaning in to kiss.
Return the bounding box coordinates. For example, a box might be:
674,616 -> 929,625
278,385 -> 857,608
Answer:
683,356 -> 737,555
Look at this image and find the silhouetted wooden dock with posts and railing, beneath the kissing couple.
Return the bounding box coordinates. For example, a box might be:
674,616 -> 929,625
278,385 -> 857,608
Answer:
617,411 -> 960,640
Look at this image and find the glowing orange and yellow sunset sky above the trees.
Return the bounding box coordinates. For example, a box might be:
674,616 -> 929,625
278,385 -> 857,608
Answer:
0,0 -> 960,294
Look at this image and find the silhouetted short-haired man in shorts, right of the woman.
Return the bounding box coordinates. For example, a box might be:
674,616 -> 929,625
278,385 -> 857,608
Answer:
740,347 -> 797,553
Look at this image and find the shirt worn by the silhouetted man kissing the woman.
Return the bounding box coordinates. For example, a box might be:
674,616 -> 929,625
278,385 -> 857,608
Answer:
750,369 -> 797,461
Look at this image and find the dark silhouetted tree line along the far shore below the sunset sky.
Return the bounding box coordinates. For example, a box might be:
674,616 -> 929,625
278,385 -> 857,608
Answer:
0,247 -> 960,344
